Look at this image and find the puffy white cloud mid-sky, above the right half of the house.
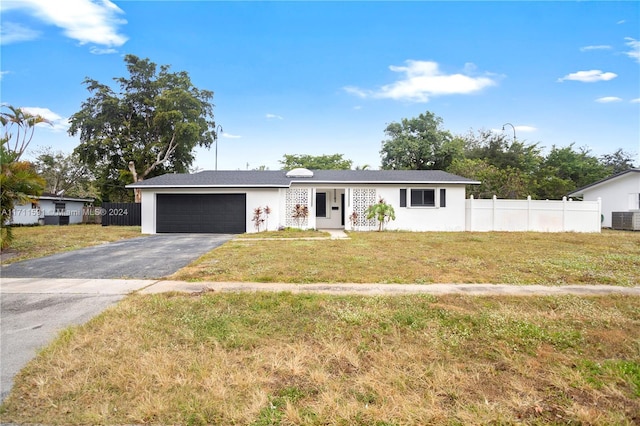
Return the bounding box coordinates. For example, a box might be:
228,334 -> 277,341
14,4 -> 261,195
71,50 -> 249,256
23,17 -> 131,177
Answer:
344,60 -> 496,102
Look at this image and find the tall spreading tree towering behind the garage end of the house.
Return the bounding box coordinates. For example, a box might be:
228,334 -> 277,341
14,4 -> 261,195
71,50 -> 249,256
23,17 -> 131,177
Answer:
69,55 -> 215,201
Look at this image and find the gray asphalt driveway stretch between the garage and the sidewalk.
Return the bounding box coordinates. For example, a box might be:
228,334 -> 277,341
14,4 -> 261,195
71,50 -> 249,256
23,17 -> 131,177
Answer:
2,234 -> 233,279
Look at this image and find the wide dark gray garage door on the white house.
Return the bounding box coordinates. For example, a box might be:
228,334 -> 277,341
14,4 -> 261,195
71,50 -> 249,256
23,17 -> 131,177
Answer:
156,194 -> 247,234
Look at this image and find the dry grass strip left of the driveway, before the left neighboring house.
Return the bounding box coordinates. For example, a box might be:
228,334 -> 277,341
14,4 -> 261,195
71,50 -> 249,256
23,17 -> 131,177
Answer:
2,225 -> 142,264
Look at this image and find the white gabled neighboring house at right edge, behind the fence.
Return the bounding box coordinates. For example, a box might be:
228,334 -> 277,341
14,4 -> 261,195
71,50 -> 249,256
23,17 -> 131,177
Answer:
569,169 -> 640,228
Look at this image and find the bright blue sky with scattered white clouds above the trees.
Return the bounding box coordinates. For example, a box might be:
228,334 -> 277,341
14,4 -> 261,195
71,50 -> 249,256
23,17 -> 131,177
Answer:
0,0 -> 640,170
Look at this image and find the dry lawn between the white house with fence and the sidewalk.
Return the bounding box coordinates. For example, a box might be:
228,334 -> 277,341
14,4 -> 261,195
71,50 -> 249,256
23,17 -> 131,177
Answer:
172,231 -> 640,286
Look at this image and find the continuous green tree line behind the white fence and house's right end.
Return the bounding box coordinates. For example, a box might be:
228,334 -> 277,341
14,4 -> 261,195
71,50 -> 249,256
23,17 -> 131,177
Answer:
380,111 -> 634,199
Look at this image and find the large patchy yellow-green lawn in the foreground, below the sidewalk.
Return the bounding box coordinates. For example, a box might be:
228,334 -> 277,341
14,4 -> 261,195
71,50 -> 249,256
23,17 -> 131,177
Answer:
0,293 -> 640,425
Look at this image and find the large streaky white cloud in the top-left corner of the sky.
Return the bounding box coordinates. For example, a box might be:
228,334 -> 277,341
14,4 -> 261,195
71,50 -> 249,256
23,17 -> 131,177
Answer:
2,0 -> 127,47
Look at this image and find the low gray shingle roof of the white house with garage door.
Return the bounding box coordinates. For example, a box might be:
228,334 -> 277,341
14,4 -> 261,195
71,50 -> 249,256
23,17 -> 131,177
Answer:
127,170 -> 480,188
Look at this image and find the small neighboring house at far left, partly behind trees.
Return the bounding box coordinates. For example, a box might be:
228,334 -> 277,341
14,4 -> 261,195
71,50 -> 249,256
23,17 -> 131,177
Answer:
11,193 -> 93,225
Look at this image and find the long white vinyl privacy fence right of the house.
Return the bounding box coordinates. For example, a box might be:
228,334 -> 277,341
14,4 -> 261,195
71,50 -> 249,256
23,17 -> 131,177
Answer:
465,196 -> 602,232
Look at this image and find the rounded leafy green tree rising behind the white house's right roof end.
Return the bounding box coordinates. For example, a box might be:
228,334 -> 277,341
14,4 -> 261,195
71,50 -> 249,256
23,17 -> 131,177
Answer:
380,111 -> 463,170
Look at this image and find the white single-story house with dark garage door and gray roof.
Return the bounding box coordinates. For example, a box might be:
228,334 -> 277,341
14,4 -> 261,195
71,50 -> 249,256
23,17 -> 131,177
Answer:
127,169 -> 479,234
